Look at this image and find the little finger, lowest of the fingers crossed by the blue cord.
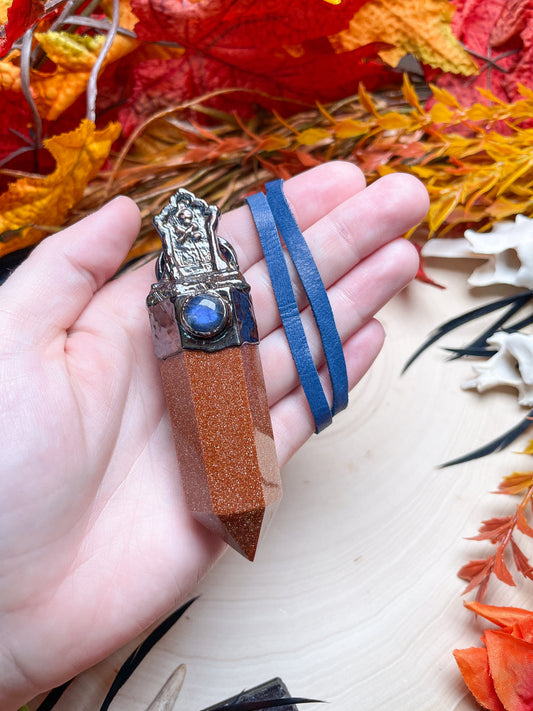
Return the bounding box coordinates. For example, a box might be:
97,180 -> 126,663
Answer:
270,320 -> 385,466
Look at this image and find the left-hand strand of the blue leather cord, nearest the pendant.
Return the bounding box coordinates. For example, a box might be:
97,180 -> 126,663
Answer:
246,193 -> 331,433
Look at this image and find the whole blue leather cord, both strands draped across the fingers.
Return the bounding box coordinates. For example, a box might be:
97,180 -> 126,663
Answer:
246,180 -> 348,433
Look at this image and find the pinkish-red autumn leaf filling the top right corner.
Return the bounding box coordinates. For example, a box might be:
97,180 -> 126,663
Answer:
427,0 -> 533,106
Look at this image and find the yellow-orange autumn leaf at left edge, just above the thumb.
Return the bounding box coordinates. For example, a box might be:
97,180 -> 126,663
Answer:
0,119 -> 120,256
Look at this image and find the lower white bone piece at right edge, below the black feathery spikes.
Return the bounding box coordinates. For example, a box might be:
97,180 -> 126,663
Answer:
462,331 -> 533,407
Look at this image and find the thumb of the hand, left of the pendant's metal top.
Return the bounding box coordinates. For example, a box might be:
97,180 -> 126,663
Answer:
0,197 -> 140,345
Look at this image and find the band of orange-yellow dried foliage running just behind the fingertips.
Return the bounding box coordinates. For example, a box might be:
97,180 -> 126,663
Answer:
79,77 -> 533,264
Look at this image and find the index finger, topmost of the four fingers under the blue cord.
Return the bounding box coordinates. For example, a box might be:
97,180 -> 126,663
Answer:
218,161 -> 365,271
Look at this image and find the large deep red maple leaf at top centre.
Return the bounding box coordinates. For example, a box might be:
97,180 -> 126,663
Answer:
120,0 -> 394,134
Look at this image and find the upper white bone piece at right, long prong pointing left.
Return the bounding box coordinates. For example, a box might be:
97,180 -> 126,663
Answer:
422,215 -> 533,289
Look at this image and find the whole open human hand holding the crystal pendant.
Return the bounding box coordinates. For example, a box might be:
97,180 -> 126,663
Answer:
0,163 -> 427,711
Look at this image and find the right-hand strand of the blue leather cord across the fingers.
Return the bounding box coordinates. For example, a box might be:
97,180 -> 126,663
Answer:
265,180 -> 348,415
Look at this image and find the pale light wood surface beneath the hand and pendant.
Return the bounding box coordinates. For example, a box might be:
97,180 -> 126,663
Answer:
30,260 -> 533,711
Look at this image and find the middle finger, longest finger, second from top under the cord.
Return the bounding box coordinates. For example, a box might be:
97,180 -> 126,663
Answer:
245,174 -> 428,337
